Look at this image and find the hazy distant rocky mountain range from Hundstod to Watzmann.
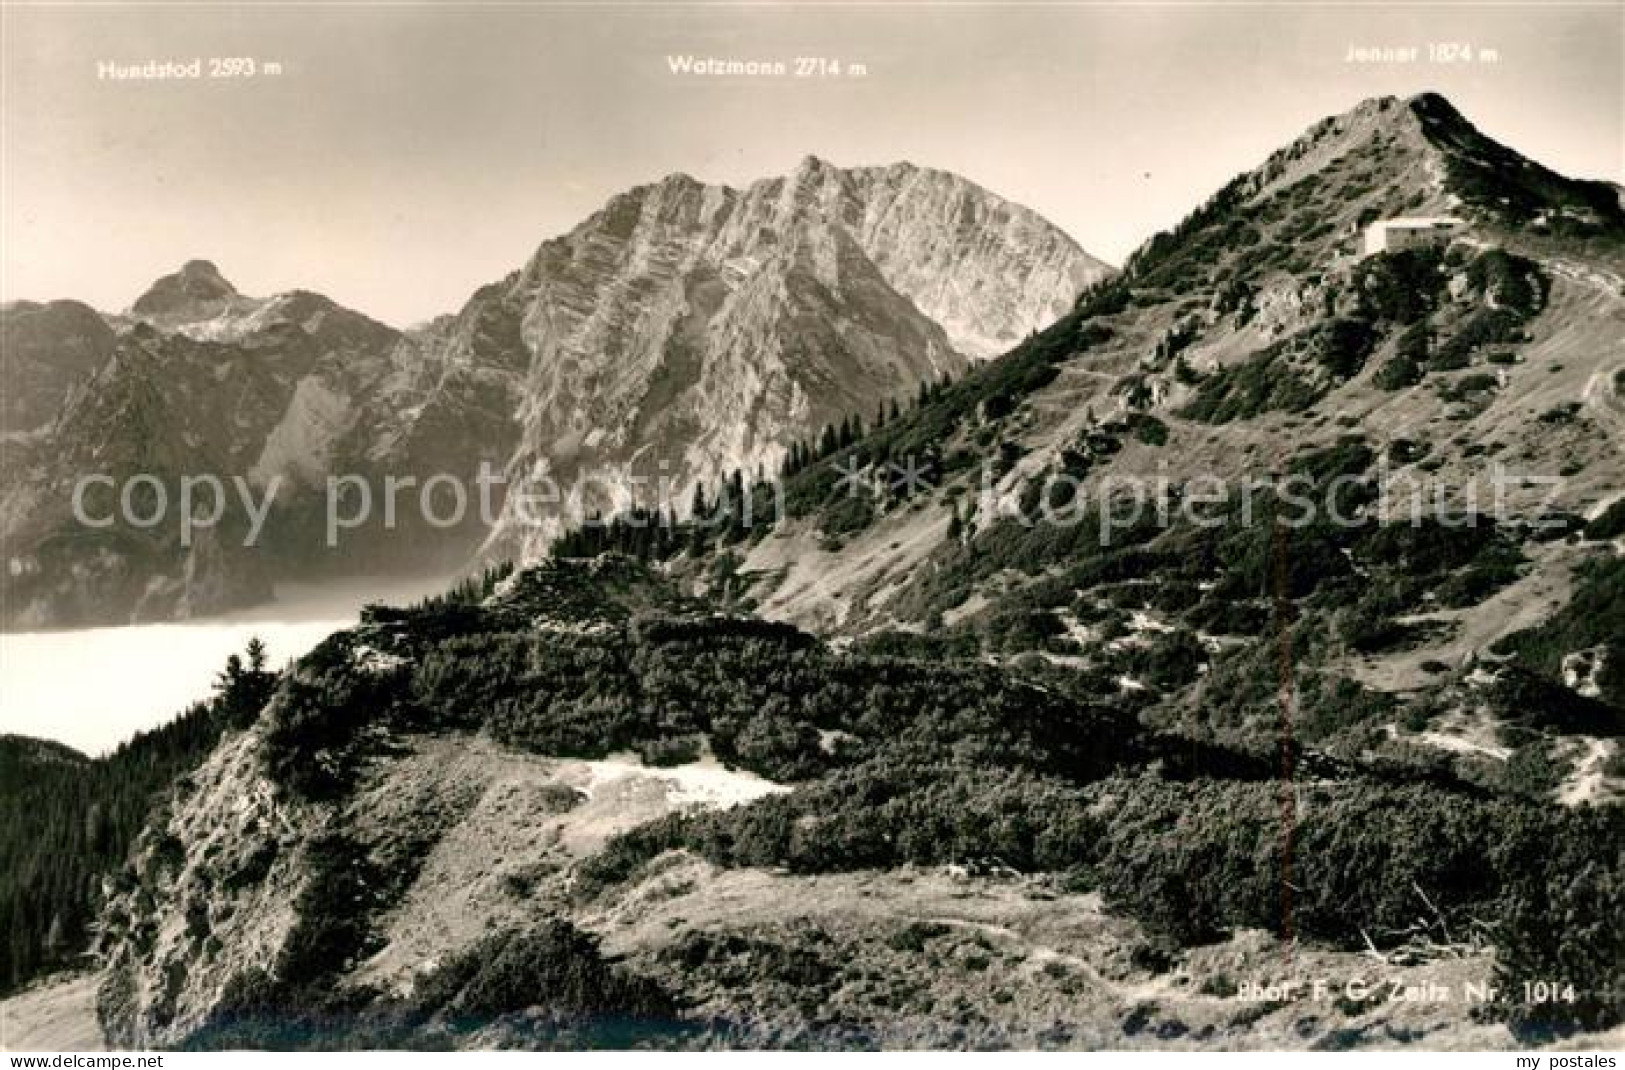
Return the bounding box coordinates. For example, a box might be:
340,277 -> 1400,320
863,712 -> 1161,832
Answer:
0,158 -> 1110,628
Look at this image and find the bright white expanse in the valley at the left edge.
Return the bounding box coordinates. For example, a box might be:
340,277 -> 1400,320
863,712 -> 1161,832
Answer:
0,577 -> 452,756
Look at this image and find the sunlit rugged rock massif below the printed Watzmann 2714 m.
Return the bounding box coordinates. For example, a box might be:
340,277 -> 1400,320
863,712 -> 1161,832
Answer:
476,158 -> 1108,558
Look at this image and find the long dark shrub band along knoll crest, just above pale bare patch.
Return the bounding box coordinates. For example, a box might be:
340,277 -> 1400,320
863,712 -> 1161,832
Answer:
265,565 -> 1157,797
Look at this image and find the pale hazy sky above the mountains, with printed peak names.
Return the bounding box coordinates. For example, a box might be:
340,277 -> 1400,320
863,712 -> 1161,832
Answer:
0,0 -> 1625,325
